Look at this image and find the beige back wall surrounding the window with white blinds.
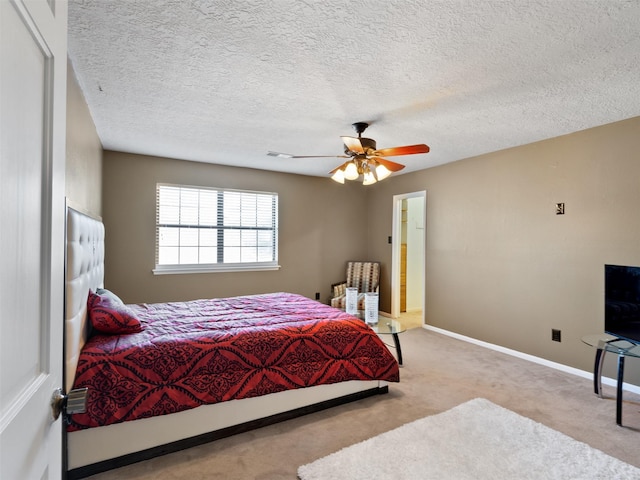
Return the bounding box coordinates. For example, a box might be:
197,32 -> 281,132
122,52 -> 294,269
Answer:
103,151 -> 367,303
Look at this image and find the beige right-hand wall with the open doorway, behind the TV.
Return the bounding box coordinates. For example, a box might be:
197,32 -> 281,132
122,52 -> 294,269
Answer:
368,117 -> 640,383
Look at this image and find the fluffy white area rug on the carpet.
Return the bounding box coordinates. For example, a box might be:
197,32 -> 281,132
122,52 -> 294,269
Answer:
298,398 -> 640,480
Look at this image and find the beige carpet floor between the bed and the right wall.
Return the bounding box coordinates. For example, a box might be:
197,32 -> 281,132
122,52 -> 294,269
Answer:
84,328 -> 640,480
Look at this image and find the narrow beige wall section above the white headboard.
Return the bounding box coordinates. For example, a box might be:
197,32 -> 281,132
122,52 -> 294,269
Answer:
65,62 -> 102,216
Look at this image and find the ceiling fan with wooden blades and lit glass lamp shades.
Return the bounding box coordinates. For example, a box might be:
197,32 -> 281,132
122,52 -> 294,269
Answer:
267,122 -> 429,185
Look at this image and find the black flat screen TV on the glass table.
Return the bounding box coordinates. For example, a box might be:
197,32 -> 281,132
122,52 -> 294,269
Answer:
604,265 -> 640,343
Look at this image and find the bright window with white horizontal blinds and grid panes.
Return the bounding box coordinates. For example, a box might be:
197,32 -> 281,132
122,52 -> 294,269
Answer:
154,184 -> 279,274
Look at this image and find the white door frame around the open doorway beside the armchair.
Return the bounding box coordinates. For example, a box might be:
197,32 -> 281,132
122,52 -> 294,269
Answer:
391,190 -> 427,318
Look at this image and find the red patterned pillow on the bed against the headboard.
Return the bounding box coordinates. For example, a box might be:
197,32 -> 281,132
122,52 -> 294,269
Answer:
87,292 -> 142,334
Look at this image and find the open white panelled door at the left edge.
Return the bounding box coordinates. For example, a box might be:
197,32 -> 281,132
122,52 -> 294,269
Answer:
0,0 -> 67,480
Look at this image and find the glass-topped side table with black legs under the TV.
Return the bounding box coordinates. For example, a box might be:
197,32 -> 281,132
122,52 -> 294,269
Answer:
582,333 -> 640,426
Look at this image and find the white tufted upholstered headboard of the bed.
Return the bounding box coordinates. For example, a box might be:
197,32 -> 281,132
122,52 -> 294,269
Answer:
64,207 -> 104,392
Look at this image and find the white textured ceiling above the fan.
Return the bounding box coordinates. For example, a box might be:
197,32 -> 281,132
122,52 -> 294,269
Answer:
69,0 -> 640,176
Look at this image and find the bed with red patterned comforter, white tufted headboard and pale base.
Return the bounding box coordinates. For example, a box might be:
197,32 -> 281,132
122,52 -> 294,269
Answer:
65,208 -> 399,478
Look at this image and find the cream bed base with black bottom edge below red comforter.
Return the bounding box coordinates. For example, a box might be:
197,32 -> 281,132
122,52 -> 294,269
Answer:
67,380 -> 389,480
